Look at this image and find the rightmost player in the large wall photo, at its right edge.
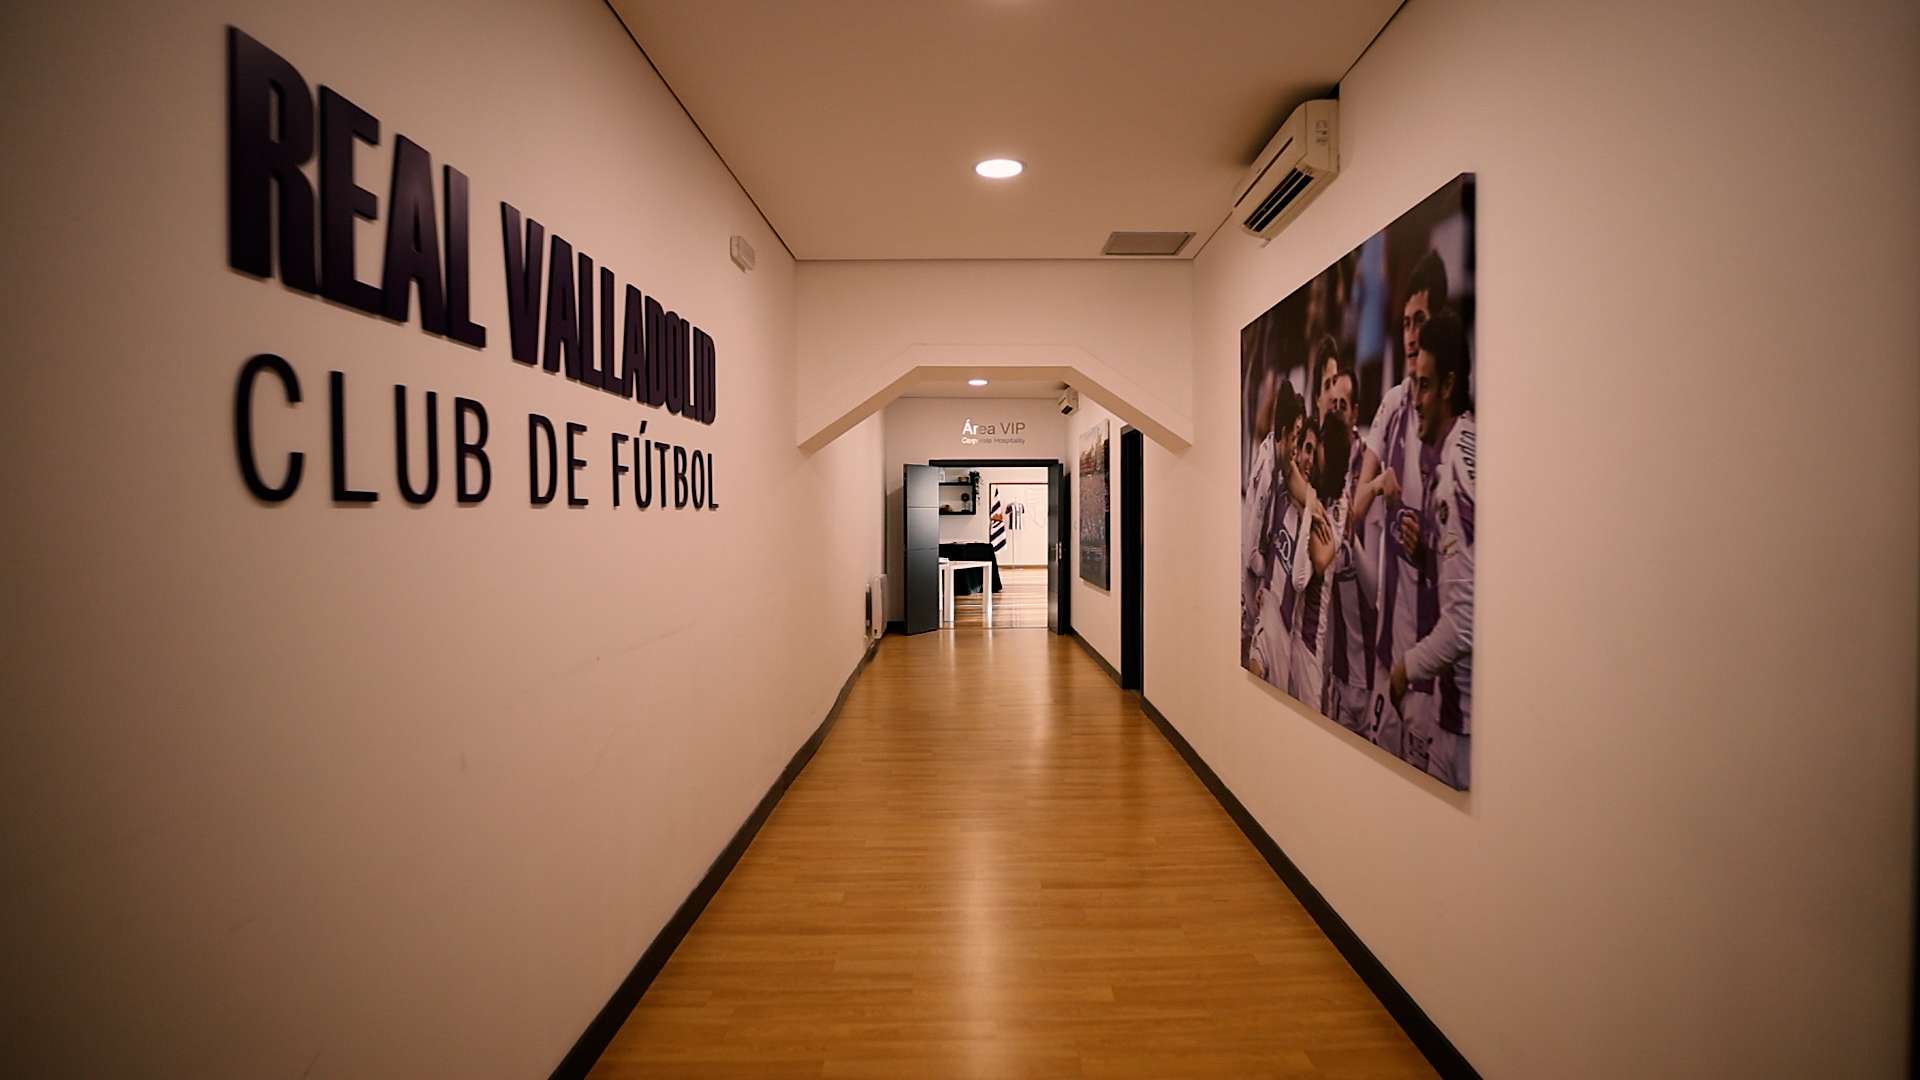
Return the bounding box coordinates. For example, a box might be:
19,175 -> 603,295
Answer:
1388,311 -> 1475,788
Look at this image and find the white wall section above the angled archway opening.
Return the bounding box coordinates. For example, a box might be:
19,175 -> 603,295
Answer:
795,259 -> 1192,442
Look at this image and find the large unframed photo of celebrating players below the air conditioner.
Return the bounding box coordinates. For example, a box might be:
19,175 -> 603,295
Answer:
1240,173 -> 1478,790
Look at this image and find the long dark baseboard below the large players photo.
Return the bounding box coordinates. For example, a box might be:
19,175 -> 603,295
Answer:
1136,691 -> 1480,1080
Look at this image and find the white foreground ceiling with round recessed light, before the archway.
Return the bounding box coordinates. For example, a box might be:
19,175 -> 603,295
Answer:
611,0 -> 1400,259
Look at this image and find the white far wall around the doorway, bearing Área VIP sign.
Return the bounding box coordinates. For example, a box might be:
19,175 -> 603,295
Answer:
879,398 -> 1068,619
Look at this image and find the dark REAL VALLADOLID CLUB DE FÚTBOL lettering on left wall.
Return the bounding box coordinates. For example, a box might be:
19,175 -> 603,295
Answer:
227,27 -> 720,509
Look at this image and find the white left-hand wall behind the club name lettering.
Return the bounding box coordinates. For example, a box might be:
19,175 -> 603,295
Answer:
0,0 -> 881,1078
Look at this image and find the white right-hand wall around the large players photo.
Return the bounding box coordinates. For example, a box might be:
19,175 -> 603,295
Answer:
1152,0 -> 1920,1078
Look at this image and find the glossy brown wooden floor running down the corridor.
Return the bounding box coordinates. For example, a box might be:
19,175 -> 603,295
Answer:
593,630 -> 1432,1080
